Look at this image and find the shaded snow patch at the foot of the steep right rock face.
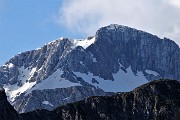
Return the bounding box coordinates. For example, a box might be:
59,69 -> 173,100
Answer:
74,67 -> 148,92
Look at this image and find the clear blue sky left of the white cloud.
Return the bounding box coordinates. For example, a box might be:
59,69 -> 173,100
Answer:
0,0 -> 83,65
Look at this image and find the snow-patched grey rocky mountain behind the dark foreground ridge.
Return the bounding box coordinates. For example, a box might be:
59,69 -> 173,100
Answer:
0,24 -> 180,113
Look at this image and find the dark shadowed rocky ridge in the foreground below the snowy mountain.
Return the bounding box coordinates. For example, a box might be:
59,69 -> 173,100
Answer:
0,79 -> 180,120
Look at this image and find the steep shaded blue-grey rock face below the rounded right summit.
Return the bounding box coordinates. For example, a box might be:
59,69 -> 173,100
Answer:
87,25 -> 180,80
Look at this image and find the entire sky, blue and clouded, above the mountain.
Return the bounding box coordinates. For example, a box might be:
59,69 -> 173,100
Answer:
0,0 -> 180,65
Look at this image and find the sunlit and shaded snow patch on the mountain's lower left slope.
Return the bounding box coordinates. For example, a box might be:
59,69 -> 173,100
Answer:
3,67 -> 82,102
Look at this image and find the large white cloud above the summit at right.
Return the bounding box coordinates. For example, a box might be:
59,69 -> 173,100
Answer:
58,0 -> 180,44
